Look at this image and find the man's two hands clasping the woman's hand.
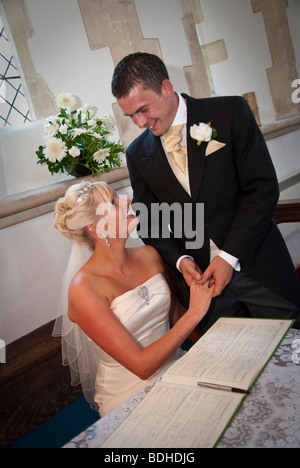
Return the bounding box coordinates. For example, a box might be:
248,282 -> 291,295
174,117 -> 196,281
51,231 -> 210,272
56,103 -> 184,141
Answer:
180,256 -> 234,297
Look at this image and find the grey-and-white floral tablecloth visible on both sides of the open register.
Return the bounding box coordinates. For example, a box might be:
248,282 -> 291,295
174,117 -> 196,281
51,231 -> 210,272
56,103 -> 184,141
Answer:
64,329 -> 300,448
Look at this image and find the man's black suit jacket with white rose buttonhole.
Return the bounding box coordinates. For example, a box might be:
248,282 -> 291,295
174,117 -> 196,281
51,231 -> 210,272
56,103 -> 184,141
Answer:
127,95 -> 300,305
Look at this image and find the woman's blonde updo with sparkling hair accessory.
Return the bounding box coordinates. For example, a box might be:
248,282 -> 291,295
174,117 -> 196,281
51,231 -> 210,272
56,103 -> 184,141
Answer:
54,182 -> 113,250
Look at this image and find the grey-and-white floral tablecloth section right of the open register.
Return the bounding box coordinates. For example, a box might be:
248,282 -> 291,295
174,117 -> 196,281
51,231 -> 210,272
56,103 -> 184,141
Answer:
219,330 -> 300,448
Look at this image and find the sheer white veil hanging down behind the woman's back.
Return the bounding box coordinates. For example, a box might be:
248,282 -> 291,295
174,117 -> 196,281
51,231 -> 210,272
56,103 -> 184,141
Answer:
53,242 -> 99,411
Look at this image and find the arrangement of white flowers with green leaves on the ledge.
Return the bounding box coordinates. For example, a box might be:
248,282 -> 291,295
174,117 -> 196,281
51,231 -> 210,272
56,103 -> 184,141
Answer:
36,93 -> 125,176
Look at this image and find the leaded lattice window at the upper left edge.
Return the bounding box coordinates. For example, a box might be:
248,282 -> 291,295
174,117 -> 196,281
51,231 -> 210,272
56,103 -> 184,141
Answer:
0,18 -> 31,127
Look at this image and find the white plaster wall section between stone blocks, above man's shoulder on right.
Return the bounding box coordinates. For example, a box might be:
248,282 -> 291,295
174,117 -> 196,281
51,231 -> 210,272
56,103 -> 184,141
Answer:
198,0 -> 275,124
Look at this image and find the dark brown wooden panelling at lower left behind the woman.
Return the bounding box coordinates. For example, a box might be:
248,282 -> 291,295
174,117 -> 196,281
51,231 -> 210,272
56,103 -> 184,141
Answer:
0,322 -> 82,448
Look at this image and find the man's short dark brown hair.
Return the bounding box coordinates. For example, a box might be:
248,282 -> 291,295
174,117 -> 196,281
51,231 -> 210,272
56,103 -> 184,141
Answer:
111,52 -> 169,99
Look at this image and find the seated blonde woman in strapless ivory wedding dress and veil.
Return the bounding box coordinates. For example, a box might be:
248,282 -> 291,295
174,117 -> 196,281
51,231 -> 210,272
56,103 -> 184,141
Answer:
54,182 -> 213,417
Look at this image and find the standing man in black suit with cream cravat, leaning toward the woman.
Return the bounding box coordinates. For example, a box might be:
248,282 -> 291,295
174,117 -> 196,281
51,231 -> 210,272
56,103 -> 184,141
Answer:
112,53 -> 300,331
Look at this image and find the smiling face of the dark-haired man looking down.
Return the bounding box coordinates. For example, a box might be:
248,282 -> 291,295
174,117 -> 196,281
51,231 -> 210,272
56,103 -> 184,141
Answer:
118,80 -> 178,136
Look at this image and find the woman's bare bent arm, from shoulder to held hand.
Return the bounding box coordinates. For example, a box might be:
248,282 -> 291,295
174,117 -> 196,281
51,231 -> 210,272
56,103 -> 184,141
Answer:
69,281 -> 213,380
